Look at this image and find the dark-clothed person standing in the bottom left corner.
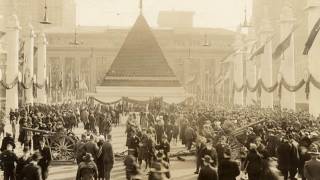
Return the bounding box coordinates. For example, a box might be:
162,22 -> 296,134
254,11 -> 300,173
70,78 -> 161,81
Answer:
0,143 -> 18,180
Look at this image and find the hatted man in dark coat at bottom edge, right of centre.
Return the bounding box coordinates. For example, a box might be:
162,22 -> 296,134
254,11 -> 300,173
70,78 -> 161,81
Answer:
198,155 -> 218,180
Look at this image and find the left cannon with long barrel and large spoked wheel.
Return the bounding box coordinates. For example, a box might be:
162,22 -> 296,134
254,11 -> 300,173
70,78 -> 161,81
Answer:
22,127 -> 79,162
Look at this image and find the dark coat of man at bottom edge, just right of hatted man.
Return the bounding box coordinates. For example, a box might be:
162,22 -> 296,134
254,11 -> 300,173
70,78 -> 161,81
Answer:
218,159 -> 240,180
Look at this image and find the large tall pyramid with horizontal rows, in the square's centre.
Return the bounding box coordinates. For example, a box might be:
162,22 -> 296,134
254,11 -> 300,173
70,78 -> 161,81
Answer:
101,15 -> 181,87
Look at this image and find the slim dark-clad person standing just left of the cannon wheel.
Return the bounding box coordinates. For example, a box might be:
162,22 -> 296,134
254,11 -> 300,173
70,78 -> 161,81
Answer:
38,139 -> 52,180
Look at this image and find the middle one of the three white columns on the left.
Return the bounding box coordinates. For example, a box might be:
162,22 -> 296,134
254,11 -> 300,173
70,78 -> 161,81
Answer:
24,25 -> 35,104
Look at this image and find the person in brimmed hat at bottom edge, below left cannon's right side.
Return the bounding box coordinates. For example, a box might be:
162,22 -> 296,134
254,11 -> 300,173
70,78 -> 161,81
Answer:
76,153 -> 98,180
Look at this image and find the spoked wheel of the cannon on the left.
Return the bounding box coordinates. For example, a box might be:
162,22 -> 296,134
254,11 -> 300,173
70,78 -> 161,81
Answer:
50,136 -> 74,160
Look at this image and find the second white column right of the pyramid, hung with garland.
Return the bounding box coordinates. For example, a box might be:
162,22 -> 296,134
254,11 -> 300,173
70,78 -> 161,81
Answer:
260,7 -> 273,108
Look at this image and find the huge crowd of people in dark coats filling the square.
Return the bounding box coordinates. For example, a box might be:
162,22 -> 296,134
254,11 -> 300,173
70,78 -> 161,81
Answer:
0,100 -> 320,180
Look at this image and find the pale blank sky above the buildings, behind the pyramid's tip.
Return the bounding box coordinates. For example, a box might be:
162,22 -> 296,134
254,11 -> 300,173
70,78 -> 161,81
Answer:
76,0 -> 252,29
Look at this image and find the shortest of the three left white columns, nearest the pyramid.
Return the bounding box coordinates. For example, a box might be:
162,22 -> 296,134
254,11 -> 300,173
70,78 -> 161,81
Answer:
37,32 -> 48,104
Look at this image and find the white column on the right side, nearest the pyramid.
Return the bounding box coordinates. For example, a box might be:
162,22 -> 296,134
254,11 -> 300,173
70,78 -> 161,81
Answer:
233,27 -> 245,106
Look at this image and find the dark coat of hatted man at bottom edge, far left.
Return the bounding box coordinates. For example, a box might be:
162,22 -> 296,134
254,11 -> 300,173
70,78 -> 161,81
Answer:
21,163 -> 42,180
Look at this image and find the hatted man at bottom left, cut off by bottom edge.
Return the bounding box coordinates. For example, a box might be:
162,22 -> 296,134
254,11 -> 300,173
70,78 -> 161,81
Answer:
21,152 -> 42,180
